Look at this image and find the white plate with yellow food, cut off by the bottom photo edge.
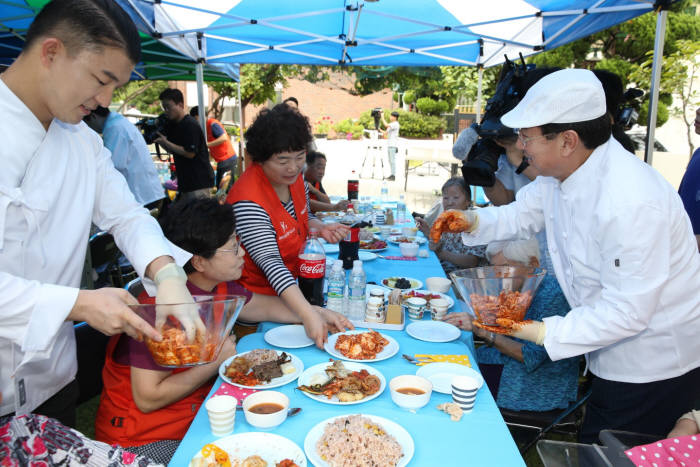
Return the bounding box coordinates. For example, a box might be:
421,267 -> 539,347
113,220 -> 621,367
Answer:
189,432 -> 307,467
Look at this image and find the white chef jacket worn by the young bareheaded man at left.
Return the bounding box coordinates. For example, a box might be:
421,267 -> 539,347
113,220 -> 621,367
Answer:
0,79 -> 173,415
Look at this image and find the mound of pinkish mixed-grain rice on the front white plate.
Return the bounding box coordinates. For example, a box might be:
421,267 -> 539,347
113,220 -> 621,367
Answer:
316,415 -> 403,467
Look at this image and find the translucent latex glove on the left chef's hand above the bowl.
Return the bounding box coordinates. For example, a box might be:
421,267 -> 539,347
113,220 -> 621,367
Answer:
153,263 -> 206,342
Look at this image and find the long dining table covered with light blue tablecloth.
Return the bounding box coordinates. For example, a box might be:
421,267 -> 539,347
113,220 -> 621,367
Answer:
170,232 -> 525,467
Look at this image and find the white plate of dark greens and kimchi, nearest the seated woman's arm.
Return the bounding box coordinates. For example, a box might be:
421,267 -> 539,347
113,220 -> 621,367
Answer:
219,349 -> 304,389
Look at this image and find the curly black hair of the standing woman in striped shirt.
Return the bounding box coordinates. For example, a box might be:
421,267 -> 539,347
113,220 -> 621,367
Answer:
244,104 -> 312,163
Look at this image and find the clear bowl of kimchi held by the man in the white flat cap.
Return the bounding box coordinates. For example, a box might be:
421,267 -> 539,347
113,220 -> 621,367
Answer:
450,266 -> 546,327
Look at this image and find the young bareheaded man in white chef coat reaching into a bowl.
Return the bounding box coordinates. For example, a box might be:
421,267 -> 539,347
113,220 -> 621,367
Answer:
0,0 -> 201,425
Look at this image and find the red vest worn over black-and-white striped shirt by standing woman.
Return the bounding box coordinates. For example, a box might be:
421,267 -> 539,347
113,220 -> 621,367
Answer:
226,162 -> 309,295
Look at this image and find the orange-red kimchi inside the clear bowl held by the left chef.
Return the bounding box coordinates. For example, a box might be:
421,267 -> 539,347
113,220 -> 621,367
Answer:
146,328 -> 216,366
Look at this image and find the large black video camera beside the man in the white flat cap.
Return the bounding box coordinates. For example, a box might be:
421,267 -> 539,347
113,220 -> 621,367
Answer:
453,55 -> 550,187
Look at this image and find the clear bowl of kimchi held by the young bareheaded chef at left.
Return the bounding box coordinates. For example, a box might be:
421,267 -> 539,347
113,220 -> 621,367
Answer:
129,295 -> 246,368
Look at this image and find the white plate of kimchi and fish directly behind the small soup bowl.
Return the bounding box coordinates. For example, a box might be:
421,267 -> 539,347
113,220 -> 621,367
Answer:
297,359 -> 386,405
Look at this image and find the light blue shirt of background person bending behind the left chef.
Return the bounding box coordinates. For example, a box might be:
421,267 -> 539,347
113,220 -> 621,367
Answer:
102,112 -> 165,205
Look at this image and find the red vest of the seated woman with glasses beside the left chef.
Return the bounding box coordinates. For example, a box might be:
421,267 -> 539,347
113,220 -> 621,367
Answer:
95,282 -> 228,446
